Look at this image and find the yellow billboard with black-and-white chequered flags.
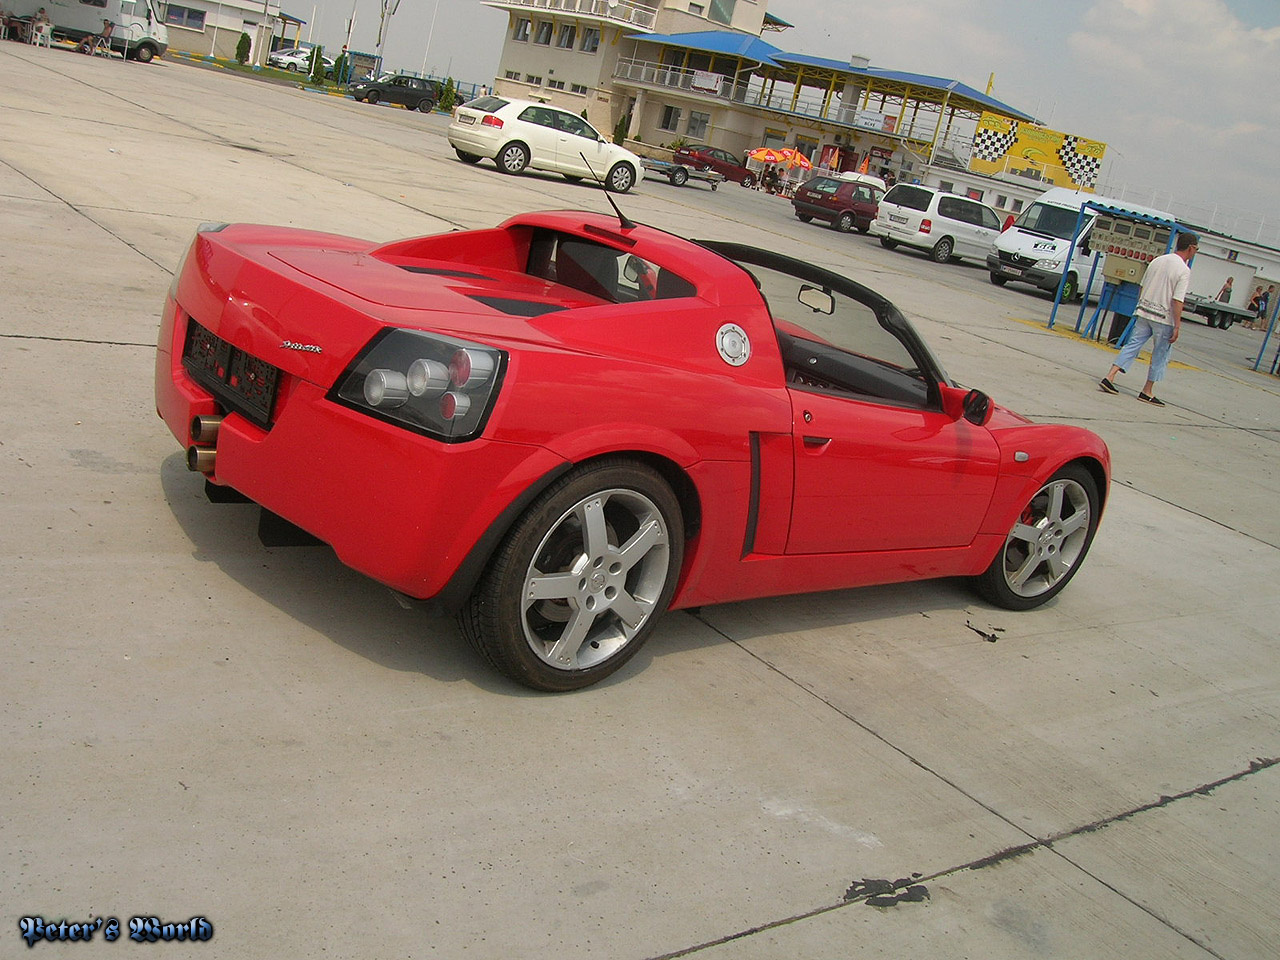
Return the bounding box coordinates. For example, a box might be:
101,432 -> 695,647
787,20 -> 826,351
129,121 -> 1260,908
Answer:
969,114 -> 1107,191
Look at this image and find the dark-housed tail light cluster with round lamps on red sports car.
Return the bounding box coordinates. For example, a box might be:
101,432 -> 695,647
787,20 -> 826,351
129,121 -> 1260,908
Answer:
330,330 -> 506,442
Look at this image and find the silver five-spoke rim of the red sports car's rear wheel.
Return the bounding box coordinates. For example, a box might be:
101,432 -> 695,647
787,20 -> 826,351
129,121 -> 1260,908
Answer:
521,488 -> 671,671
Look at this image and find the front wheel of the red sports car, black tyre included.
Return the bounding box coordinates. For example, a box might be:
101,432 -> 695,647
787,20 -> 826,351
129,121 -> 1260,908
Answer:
974,463 -> 1098,611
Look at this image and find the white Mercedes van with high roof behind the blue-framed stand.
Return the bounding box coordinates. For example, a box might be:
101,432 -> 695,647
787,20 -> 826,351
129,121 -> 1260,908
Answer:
987,187 -> 1175,301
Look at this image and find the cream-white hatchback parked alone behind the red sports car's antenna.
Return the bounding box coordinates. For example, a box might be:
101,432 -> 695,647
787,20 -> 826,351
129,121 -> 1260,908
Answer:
449,96 -> 644,193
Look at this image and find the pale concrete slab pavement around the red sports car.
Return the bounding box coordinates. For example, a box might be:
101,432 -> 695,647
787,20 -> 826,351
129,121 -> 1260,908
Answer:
0,44 -> 1280,960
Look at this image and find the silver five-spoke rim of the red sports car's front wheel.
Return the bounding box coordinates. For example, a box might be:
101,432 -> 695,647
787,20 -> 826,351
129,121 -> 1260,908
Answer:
1001,477 -> 1091,596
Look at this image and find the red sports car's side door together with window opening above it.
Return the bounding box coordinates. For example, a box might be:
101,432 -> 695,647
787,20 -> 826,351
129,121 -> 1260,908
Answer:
767,271 -> 1000,554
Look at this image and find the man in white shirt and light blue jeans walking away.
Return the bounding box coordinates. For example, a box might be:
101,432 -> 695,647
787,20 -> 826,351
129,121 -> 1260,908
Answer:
1098,233 -> 1199,407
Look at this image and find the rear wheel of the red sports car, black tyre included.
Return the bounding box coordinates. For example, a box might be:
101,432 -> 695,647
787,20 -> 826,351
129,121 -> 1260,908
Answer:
458,457 -> 685,691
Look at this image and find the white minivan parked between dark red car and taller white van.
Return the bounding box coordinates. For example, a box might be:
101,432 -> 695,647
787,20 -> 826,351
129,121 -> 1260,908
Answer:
870,183 -> 1000,264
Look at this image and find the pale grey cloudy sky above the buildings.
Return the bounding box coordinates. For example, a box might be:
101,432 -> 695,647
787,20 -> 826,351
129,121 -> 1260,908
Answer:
294,0 -> 1280,243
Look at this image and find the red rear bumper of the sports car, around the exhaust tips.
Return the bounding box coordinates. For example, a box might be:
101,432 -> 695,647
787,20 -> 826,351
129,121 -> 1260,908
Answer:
155,300 -> 564,599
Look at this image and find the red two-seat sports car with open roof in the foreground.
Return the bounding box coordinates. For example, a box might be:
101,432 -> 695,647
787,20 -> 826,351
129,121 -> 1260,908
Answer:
156,211 -> 1110,690
